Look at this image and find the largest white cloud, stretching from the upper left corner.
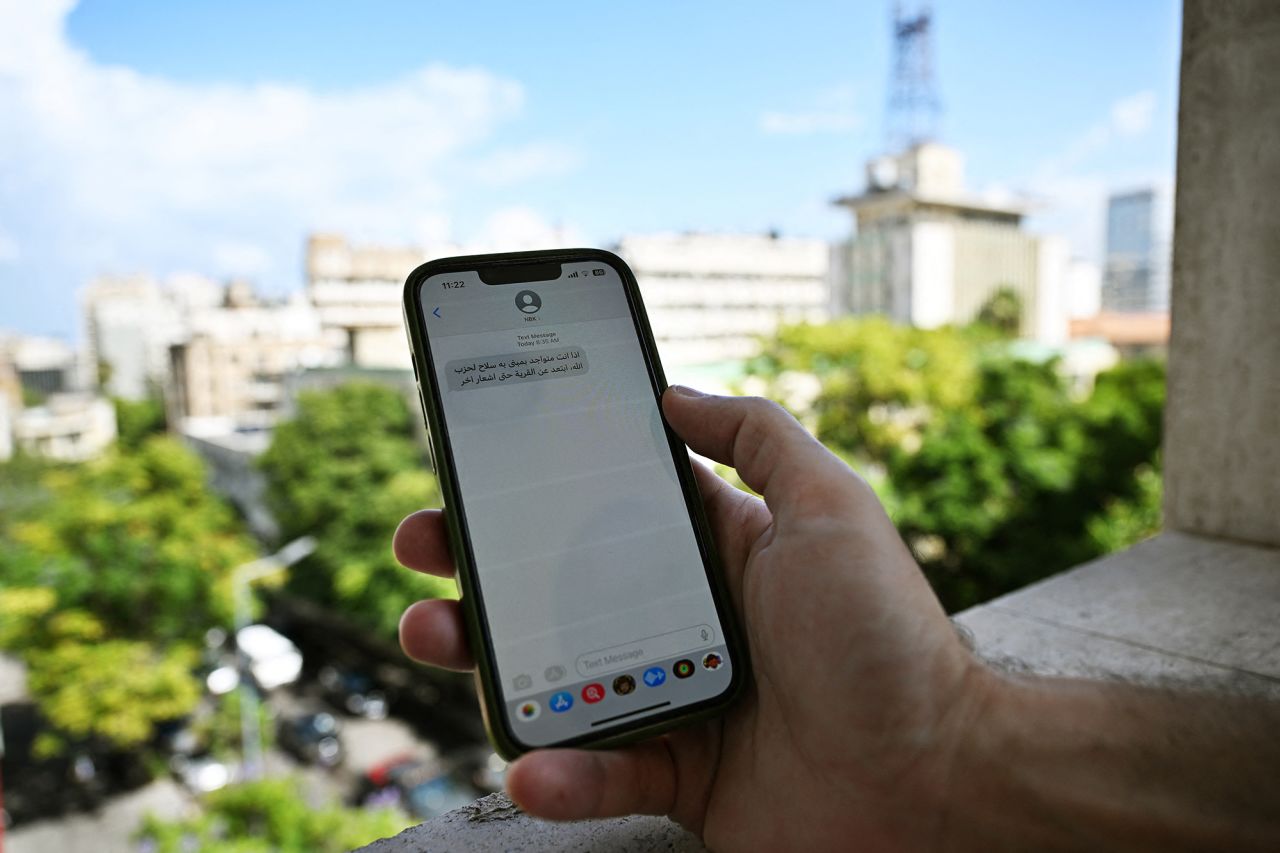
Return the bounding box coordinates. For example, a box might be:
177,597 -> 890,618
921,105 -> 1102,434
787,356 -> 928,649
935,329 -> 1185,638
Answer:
0,0 -> 576,327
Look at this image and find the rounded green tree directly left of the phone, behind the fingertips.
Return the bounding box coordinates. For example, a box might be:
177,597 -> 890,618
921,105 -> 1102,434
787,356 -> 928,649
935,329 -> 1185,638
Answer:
260,383 -> 454,637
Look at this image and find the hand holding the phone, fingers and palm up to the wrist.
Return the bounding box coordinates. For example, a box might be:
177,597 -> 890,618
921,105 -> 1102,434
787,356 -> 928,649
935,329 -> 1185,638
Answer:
394,388 -> 996,849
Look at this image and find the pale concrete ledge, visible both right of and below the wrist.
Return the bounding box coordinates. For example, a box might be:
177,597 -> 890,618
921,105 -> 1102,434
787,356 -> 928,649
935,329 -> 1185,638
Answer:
364,533 -> 1280,853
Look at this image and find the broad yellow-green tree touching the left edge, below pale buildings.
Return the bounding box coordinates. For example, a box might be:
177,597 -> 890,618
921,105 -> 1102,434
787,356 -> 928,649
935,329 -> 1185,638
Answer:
0,437 -> 255,642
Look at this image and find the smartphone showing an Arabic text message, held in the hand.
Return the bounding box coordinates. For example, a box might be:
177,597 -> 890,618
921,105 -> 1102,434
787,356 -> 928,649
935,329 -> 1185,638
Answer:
404,248 -> 748,758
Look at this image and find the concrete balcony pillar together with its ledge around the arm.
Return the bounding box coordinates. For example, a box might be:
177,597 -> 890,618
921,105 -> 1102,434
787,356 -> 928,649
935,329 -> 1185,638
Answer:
353,0 -> 1280,853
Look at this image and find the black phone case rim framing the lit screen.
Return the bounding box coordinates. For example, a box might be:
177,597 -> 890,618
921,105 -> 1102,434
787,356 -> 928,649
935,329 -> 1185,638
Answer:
403,248 -> 750,761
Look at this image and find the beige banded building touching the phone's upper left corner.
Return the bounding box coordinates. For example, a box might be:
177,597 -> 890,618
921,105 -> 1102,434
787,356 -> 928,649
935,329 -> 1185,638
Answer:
306,234 -> 437,370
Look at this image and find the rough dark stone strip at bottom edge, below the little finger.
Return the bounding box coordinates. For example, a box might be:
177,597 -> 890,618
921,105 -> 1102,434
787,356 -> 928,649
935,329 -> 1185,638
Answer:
362,794 -> 707,853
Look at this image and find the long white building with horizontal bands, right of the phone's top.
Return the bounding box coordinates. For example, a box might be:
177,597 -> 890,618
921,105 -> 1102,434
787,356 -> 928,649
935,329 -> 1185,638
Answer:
617,233 -> 831,370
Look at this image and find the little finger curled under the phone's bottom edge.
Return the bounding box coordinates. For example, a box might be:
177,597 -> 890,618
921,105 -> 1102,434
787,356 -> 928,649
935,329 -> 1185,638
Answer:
507,740 -> 676,821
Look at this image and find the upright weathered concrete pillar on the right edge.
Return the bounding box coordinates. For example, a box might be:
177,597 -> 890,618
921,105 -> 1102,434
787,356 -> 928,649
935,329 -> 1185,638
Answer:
1165,0 -> 1280,546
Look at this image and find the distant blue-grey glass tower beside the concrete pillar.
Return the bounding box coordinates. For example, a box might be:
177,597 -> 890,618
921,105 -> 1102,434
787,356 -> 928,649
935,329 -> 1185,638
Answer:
1102,188 -> 1172,313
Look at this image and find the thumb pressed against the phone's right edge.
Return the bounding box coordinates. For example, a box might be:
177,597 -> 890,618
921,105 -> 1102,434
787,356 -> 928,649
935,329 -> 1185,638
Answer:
662,386 -> 869,525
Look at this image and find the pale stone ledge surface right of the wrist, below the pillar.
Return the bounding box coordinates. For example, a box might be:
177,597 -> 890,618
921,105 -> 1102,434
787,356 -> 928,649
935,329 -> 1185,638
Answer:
956,533 -> 1280,695
